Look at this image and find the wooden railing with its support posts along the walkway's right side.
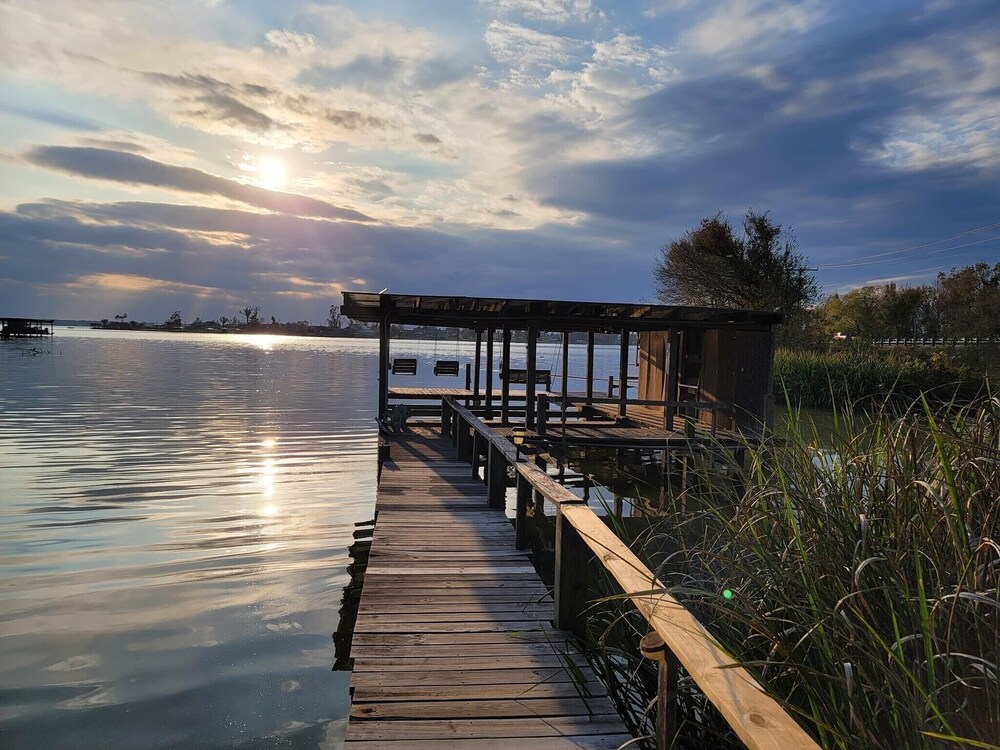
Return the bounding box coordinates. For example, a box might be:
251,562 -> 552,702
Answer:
441,398 -> 819,750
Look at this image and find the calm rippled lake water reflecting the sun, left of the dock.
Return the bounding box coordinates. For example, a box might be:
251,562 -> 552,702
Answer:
0,329 -> 632,750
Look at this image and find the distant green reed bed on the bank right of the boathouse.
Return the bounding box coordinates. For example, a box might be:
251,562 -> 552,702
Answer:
774,346 -> 984,408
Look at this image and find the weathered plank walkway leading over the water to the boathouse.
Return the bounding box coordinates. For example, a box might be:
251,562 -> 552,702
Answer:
347,428 -> 631,750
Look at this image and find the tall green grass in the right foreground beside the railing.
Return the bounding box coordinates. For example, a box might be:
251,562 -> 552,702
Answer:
590,398 -> 1000,750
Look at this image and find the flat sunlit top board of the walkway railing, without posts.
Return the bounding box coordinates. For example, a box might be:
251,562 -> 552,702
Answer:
442,398 -> 819,750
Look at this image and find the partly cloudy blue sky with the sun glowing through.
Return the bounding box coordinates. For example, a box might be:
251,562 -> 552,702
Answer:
0,0 -> 1000,322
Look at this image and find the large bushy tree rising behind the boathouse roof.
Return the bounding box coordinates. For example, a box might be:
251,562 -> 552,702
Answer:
653,209 -> 818,316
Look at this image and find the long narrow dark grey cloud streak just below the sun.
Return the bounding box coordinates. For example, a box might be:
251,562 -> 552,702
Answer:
27,146 -> 372,221
